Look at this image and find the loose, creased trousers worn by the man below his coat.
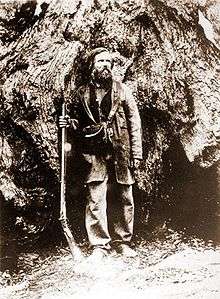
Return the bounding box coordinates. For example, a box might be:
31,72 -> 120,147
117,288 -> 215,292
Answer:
85,176 -> 134,249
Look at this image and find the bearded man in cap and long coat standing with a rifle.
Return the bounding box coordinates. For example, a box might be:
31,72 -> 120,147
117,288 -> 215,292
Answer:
59,48 -> 142,258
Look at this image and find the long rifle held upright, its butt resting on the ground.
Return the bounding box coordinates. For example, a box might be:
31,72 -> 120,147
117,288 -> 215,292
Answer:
59,103 -> 82,260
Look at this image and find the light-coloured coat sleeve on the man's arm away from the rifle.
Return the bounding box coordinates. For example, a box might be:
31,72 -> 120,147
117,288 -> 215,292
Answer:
124,85 -> 143,160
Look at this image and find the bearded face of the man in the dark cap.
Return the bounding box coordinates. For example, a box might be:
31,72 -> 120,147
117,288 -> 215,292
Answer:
92,52 -> 112,85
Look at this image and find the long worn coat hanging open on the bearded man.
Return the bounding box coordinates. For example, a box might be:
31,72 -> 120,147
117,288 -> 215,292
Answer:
69,81 -> 142,184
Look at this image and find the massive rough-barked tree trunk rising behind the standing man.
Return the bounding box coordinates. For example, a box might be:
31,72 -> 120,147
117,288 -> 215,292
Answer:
0,0 -> 220,247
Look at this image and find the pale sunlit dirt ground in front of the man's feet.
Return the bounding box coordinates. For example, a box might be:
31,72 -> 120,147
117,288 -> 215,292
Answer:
0,233 -> 220,299
